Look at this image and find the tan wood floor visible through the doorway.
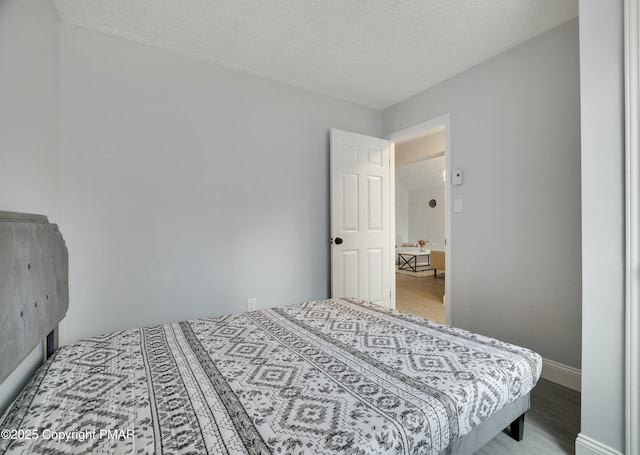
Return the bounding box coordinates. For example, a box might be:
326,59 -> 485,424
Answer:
396,273 -> 446,323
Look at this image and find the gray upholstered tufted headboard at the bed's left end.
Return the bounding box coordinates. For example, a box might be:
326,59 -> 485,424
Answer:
0,211 -> 69,382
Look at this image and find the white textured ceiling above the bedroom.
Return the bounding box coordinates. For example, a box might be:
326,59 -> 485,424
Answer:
53,0 -> 578,109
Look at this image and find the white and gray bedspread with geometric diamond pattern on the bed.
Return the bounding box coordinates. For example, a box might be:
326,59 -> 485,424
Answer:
0,300 -> 542,454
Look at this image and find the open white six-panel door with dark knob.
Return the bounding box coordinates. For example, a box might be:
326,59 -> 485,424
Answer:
330,129 -> 393,307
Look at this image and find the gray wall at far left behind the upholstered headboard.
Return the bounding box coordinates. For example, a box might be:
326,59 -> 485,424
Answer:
0,0 -> 60,414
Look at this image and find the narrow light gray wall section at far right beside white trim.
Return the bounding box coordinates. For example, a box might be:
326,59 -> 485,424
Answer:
576,0 -> 625,454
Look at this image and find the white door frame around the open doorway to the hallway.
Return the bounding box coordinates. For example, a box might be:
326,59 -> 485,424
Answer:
384,114 -> 453,325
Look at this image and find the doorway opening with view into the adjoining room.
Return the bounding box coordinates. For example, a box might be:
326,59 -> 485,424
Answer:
386,115 -> 452,323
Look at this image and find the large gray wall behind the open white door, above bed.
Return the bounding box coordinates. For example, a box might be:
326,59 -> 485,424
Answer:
61,23 -> 382,341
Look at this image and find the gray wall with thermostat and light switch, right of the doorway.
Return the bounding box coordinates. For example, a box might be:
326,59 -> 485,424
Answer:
383,19 -> 584,368
